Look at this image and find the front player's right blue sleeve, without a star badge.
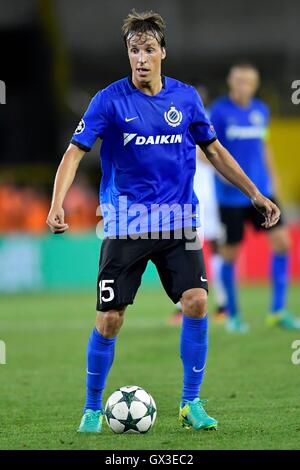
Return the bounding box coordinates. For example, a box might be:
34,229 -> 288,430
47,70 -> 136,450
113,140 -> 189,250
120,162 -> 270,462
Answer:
190,88 -> 217,147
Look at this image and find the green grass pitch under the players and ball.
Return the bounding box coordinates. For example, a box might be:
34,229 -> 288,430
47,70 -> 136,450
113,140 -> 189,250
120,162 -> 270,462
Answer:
0,286 -> 300,450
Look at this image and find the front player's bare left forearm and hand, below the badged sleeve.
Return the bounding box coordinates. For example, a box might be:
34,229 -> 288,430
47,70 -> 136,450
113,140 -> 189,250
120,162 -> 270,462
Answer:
46,144 -> 85,233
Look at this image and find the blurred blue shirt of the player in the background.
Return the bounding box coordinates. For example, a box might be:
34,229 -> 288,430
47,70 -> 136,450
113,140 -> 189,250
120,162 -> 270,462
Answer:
210,96 -> 273,207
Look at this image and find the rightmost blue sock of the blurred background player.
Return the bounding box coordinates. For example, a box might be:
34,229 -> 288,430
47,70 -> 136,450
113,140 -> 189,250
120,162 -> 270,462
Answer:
271,253 -> 289,314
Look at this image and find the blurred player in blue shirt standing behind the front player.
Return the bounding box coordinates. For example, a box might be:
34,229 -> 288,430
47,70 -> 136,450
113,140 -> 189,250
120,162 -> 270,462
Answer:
210,63 -> 300,332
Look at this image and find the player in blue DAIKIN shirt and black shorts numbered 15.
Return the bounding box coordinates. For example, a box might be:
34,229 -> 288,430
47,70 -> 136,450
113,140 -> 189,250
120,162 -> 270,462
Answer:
47,11 -> 280,432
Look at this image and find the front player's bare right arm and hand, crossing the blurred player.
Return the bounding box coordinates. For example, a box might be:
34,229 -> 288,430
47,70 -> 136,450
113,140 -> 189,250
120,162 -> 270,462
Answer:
203,139 -> 280,228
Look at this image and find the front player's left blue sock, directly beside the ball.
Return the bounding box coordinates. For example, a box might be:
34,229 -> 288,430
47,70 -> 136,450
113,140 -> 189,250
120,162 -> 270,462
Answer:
84,328 -> 116,411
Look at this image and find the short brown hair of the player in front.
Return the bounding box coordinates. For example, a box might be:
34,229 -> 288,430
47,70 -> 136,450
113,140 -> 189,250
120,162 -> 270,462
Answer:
122,9 -> 166,47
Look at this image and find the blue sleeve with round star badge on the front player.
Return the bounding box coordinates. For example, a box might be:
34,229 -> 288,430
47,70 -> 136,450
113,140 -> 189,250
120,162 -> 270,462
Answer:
71,91 -> 108,152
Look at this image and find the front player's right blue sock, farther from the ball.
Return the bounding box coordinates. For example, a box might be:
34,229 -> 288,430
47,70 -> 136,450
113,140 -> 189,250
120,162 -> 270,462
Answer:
180,315 -> 208,402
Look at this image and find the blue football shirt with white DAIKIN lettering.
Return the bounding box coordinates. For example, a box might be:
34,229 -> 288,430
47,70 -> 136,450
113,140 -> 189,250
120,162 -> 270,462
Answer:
71,77 -> 216,236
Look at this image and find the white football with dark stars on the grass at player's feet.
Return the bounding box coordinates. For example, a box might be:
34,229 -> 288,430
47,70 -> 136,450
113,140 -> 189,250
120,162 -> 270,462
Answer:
105,385 -> 156,434
